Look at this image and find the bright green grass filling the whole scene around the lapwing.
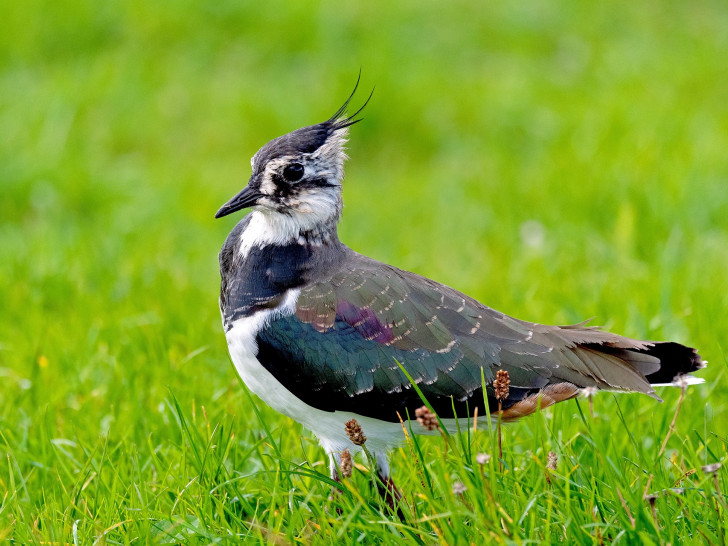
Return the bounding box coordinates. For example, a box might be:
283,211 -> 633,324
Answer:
0,0 -> 728,544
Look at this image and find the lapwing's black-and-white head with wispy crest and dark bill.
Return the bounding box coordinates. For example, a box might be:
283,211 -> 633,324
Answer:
215,82 -> 371,236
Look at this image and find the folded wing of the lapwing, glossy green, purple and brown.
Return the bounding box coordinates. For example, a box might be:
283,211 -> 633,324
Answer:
258,253 -> 655,418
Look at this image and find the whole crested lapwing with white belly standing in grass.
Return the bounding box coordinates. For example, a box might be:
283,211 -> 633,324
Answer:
215,84 -> 705,494
